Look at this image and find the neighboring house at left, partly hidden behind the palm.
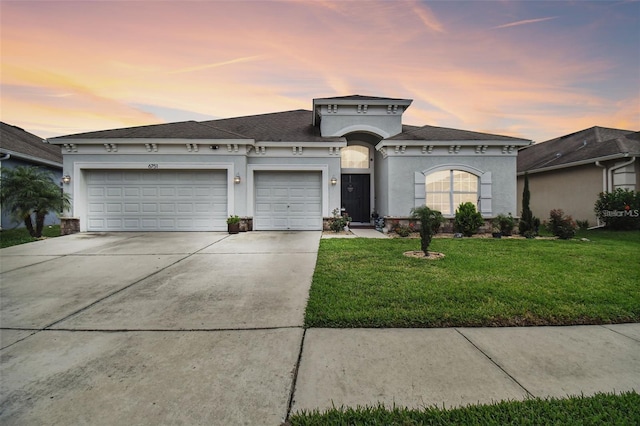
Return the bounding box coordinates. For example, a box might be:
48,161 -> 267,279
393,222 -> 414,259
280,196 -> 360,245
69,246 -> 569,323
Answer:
0,122 -> 62,229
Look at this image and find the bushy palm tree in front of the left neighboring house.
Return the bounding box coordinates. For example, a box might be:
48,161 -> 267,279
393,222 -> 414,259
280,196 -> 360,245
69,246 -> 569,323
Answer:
0,166 -> 70,238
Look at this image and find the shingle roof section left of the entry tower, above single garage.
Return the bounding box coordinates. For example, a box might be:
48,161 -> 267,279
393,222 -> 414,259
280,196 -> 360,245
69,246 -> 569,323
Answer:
202,109 -> 345,142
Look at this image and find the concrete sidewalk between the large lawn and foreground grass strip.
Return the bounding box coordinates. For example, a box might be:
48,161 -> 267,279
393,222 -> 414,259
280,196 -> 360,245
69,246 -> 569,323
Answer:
293,324 -> 640,411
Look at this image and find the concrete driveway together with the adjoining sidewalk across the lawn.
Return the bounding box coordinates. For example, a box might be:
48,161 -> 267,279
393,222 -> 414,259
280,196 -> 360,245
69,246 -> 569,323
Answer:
0,230 -> 640,425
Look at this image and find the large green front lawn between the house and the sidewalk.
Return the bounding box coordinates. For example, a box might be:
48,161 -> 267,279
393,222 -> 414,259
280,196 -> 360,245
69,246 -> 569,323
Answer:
305,230 -> 640,327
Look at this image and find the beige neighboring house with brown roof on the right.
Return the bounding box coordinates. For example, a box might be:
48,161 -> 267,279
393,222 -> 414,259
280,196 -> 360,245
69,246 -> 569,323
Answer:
518,127 -> 640,226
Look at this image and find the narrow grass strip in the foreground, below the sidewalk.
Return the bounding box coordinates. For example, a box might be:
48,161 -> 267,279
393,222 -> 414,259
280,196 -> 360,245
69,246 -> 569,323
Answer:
286,392 -> 640,426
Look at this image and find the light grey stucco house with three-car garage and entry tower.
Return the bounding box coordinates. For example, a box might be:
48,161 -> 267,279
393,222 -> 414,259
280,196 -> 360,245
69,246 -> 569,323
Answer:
48,95 -> 531,231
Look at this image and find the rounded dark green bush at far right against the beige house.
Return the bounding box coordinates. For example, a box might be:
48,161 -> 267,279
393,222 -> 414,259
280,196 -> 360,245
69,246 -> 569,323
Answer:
594,188 -> 640,231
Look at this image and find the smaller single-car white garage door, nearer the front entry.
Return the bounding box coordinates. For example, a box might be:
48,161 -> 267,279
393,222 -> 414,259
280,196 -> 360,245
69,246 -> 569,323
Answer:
253,172 -> 322,231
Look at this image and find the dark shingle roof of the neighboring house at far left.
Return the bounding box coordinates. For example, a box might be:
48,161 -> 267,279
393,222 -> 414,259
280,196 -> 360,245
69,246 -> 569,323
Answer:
0,122 -> 62,164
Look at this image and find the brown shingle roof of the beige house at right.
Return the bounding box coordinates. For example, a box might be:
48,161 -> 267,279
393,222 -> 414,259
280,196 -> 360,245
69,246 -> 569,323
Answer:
518,127 -> 640,172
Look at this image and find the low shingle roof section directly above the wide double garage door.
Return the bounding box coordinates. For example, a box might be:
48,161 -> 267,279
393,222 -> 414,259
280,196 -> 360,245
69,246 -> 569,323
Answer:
49,121 -> 247,141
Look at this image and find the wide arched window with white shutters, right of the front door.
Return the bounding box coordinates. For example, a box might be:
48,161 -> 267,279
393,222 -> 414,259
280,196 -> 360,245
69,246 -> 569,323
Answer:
425,170 -> 479,216
